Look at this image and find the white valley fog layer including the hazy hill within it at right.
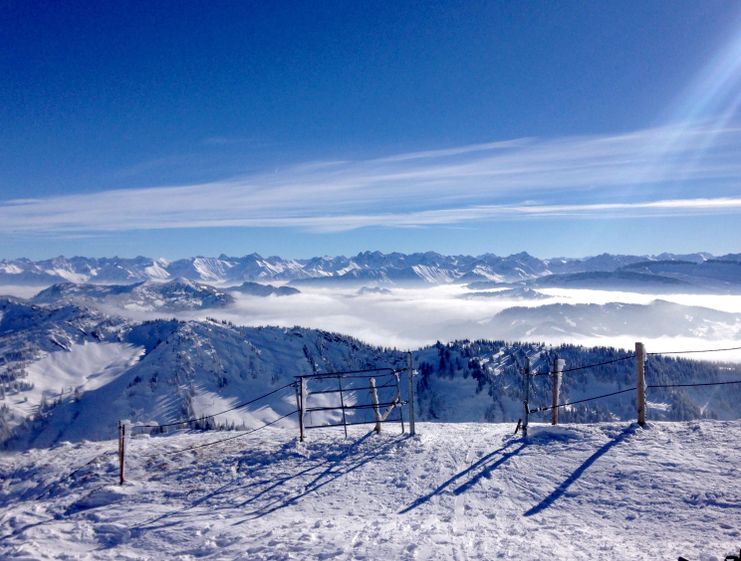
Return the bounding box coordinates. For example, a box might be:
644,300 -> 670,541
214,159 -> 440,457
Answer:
0,285 -> 741,361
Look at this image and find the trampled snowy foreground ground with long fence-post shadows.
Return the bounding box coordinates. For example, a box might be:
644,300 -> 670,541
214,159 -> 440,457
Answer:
0,421 -> 741,561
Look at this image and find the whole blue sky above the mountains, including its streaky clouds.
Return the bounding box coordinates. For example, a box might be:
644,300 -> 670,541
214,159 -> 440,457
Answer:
0,0 -> 741,258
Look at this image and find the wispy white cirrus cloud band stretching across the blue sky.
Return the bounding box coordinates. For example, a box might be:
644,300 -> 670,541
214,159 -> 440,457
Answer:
0,124 -> 741,233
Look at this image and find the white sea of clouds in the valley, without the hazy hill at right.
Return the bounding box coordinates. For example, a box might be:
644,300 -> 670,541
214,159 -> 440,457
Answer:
5,285 -> 741,362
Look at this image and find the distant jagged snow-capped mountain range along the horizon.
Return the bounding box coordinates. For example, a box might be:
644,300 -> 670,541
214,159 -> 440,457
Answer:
0,251 -> 741,290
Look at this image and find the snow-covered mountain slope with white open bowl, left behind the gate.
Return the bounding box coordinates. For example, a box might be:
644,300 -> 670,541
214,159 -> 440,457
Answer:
0,307 -> 401,447
